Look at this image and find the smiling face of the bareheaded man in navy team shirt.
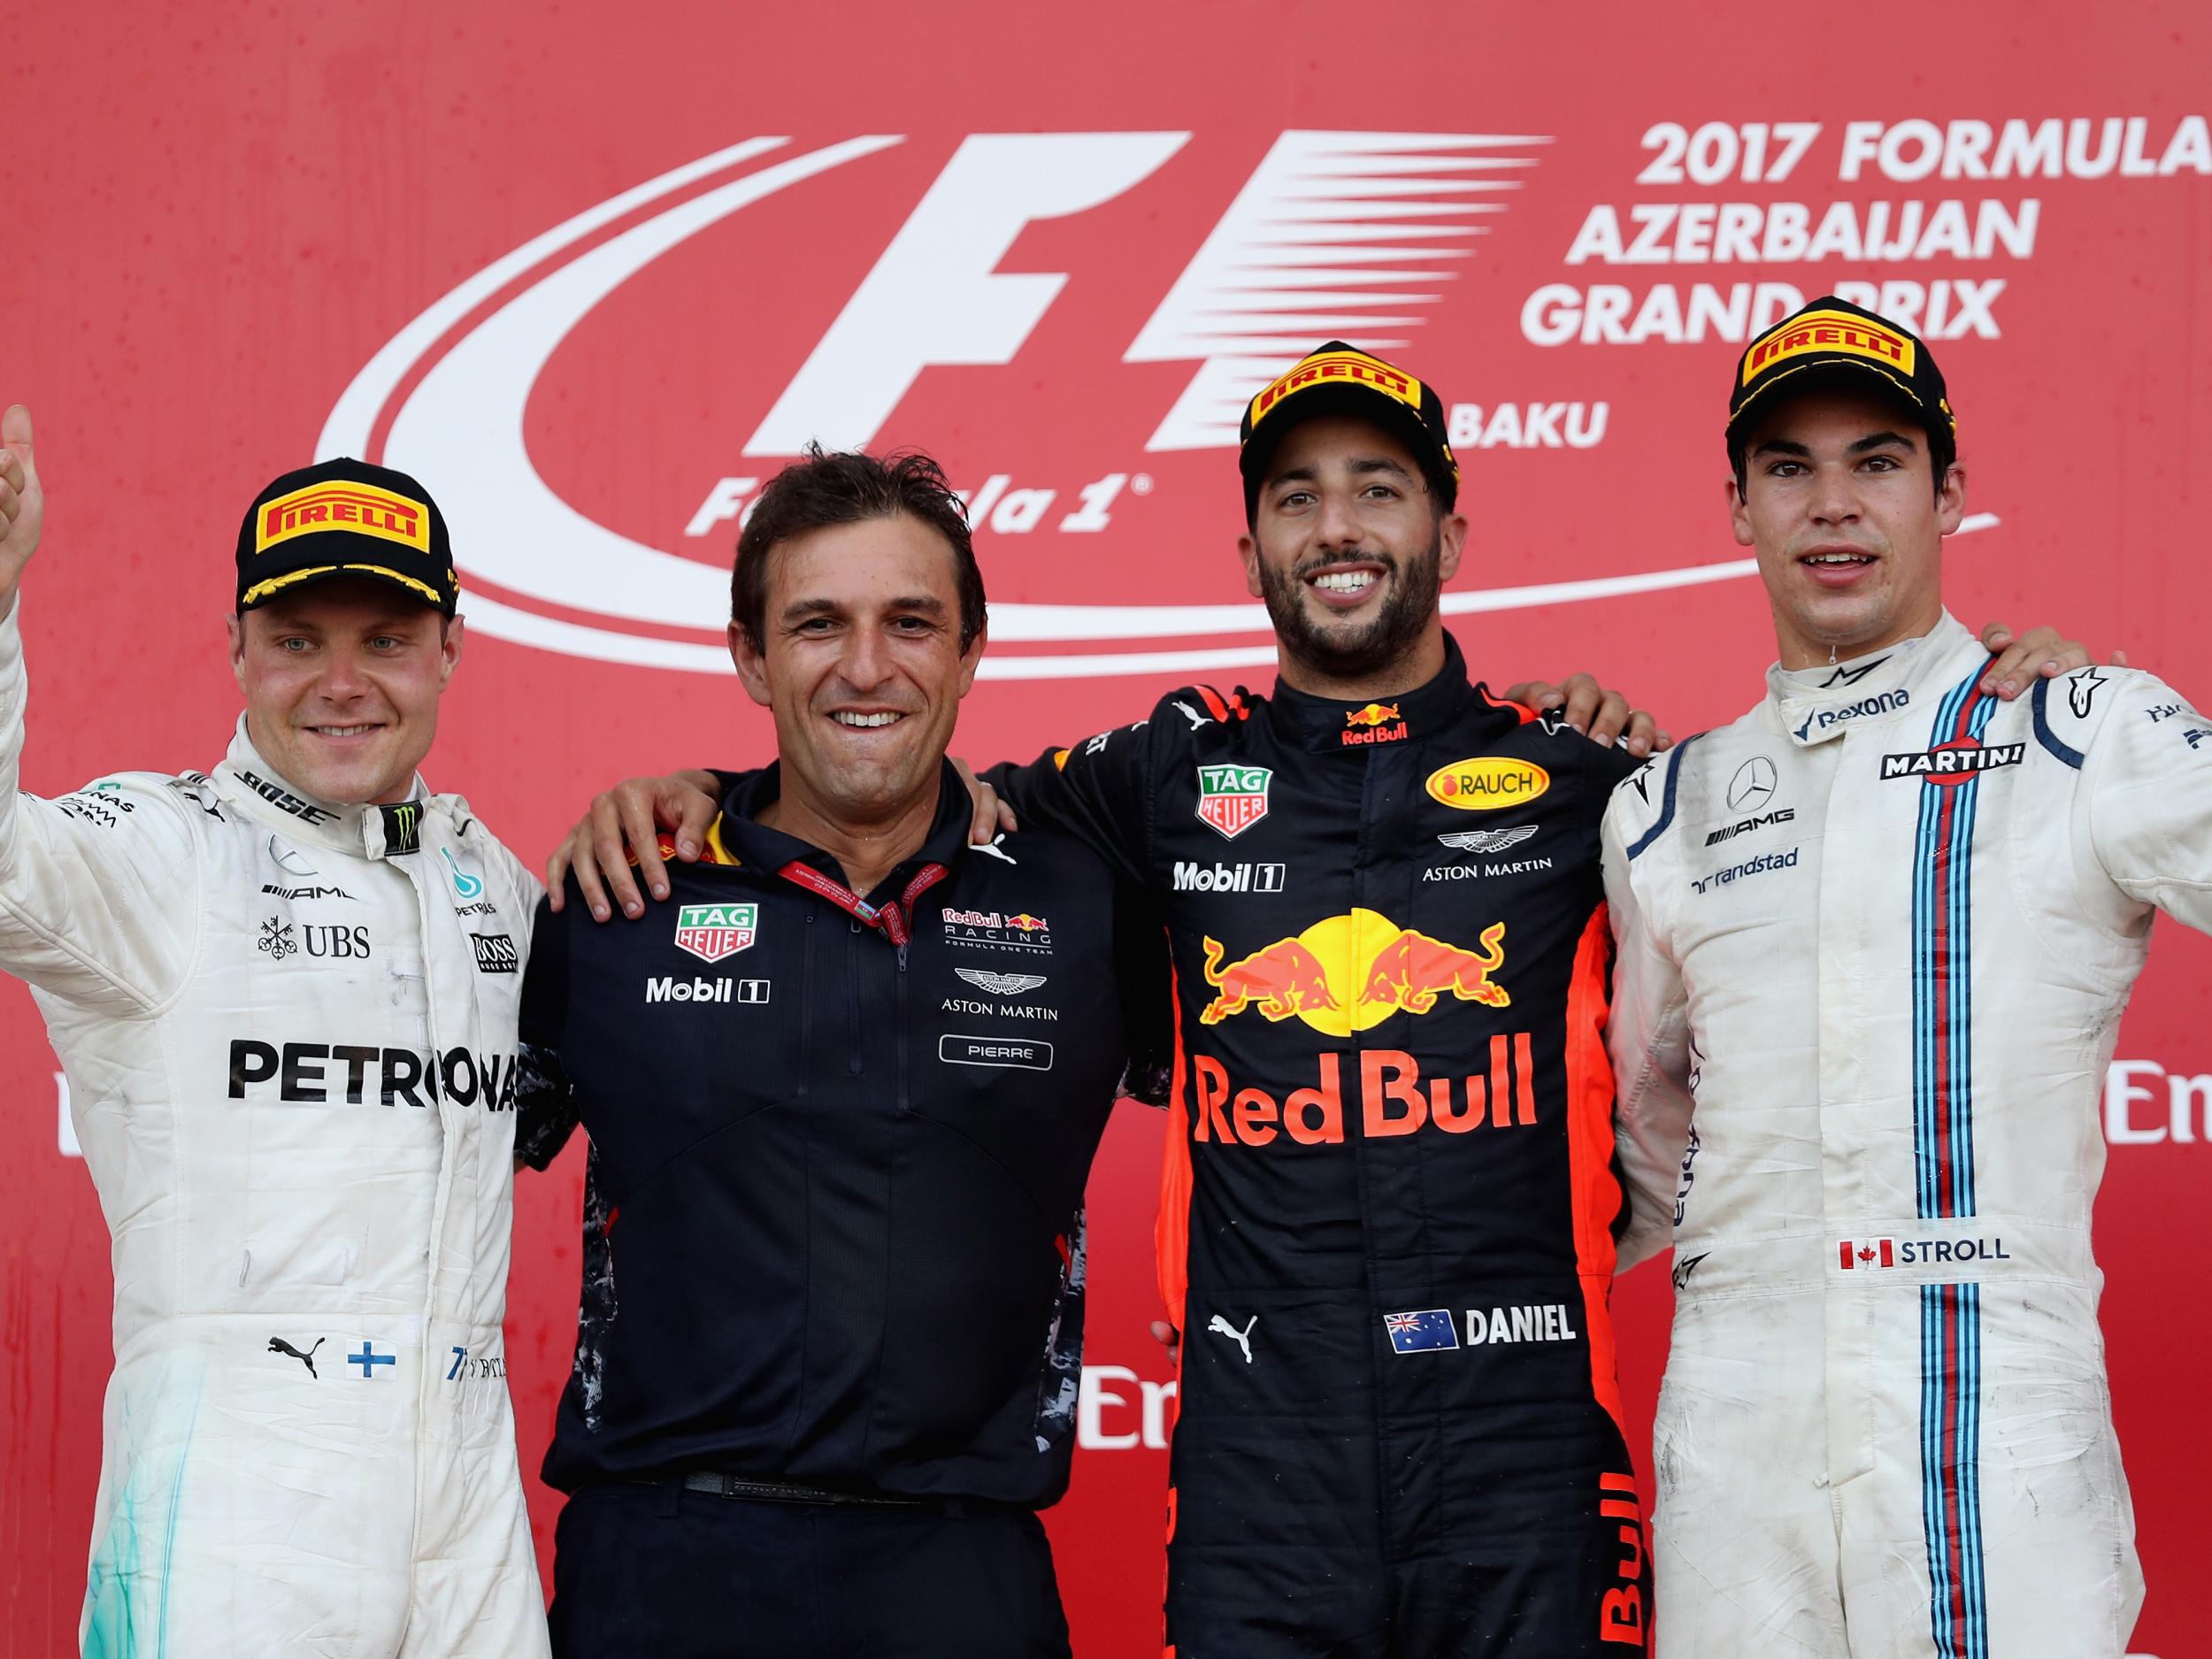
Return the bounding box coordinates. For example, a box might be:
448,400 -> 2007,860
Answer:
730,513 -> 985,826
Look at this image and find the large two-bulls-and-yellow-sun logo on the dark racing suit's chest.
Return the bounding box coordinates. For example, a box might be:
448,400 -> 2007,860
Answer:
1199,910 -> 1513,1038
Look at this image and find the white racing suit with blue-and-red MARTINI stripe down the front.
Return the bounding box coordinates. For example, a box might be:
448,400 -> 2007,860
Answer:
1606,618 -> 2212,1659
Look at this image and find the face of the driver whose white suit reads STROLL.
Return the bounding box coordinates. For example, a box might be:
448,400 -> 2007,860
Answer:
1728,388 -> 1967,668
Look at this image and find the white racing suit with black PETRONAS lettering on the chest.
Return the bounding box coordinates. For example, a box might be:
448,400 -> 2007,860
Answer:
0,615 -> 547,1659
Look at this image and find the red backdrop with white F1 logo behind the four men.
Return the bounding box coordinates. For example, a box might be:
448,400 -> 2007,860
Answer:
0,0 -> 2212,1659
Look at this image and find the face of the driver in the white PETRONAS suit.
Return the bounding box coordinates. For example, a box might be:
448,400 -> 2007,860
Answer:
230,575 -> 460,805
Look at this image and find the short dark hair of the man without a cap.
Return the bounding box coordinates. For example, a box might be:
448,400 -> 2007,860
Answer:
730,442 -> 985,650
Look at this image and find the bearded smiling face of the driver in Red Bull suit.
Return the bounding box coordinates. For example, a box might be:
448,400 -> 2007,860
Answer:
1237,416 -> 1467,697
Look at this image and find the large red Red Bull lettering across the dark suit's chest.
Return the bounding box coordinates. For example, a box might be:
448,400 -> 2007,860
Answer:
1190,1031 -> 1535,1146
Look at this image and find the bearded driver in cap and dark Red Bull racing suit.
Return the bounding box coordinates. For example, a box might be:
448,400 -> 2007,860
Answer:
987,345 -> 1648,1659
